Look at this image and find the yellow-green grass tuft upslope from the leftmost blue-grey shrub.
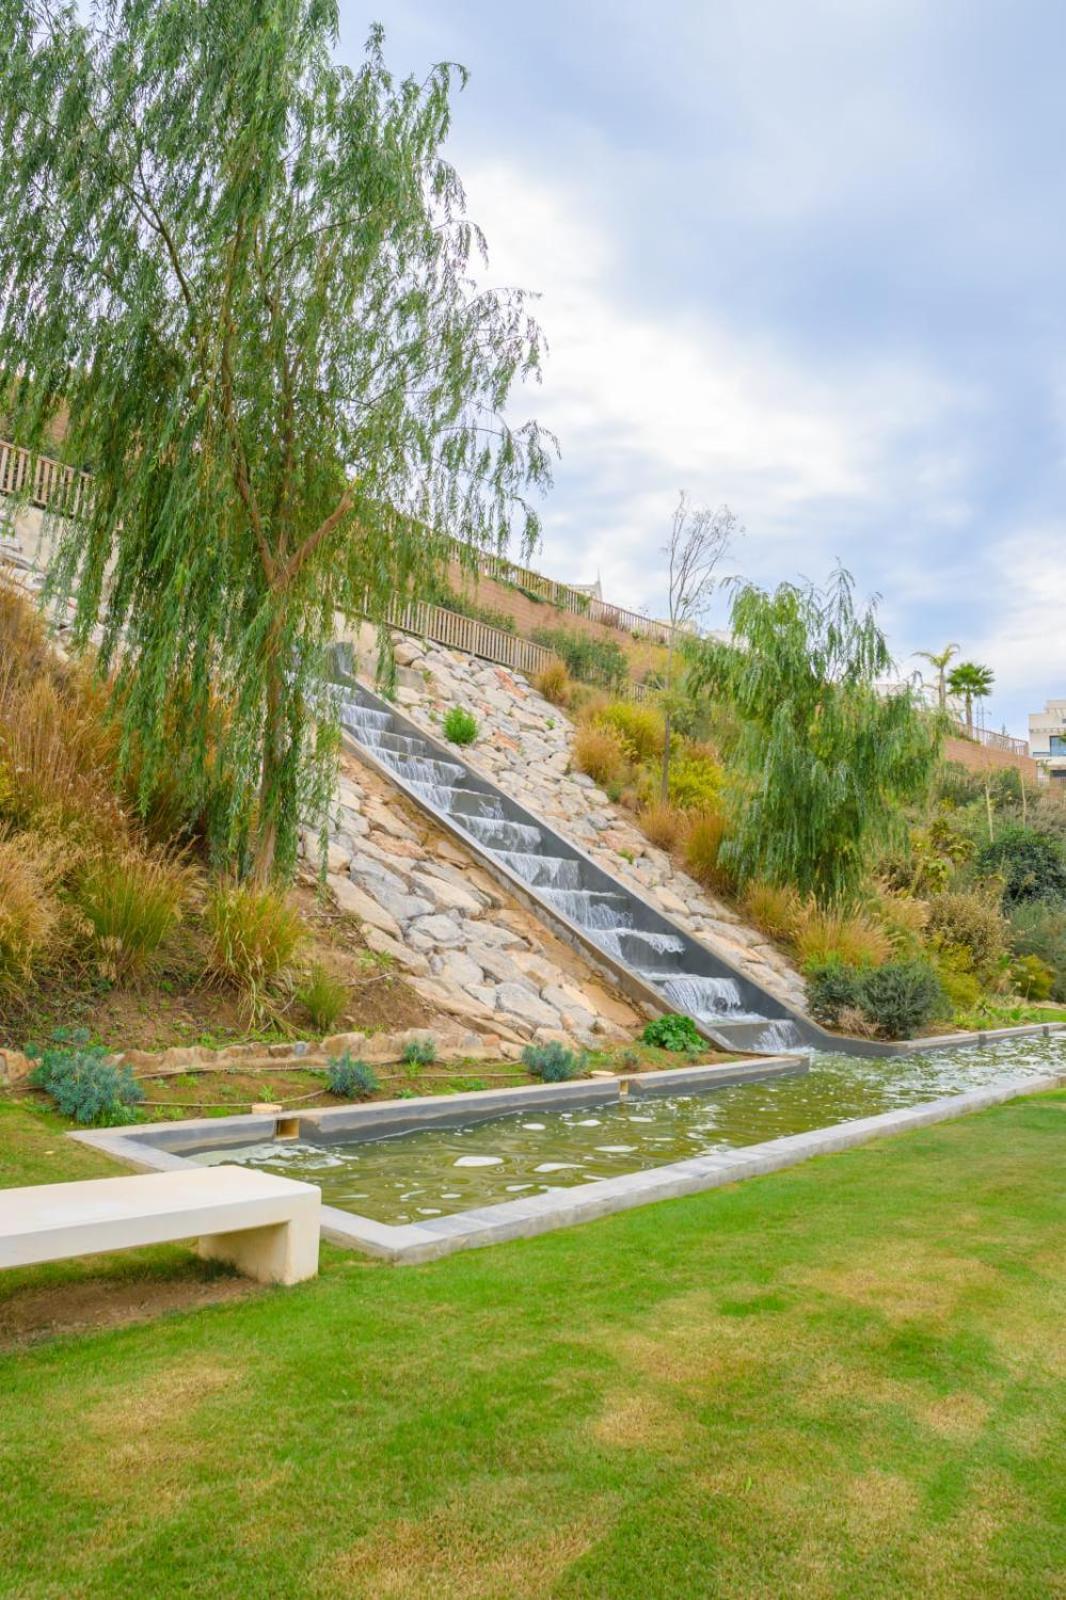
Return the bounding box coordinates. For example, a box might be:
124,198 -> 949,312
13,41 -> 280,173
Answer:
77,854 -> 186,982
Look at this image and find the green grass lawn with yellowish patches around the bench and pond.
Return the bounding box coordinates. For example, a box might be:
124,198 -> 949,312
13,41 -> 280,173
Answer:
0,1093 -> 1066,1600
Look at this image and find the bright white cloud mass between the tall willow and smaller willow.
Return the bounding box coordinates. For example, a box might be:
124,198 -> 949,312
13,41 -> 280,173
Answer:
466,163 -> 973,610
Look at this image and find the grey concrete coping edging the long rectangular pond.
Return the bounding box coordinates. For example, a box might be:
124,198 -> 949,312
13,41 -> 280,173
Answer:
67,1029 -> 1066,1266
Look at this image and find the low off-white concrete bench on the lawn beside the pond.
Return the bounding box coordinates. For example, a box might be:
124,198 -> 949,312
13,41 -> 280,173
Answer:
0,1166 -> 322,1283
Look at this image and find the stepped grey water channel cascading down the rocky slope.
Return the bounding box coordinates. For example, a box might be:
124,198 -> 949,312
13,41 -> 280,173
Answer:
336,677 -> 826,1053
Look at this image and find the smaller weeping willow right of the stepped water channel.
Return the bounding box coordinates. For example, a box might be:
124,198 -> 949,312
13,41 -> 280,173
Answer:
690,570 -> 940,904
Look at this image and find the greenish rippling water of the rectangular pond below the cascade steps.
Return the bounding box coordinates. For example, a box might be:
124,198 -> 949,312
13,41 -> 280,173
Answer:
182,1034 -> 1066,1229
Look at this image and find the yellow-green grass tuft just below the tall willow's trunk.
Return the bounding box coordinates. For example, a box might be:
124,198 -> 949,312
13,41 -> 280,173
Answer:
206,883 -> 301,1022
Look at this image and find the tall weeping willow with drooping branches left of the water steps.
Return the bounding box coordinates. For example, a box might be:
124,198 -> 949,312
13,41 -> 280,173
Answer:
0,0 -> 552,880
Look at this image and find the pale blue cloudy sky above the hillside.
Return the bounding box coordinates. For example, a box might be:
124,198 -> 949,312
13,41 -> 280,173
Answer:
341,0 -> 1066,734
